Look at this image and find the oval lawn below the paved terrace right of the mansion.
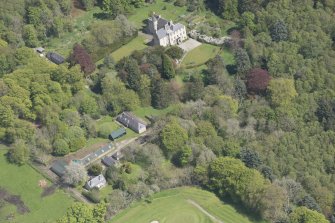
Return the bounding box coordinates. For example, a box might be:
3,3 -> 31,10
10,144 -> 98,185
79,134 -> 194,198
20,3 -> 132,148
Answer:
182,44 -> 220,67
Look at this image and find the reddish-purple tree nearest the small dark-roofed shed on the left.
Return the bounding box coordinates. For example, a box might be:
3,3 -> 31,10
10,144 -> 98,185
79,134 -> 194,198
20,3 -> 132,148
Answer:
70,44 -> 95,74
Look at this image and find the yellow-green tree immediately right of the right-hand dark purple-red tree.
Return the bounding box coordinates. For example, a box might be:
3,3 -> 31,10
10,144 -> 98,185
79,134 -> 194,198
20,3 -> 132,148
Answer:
269,78 -> 298,107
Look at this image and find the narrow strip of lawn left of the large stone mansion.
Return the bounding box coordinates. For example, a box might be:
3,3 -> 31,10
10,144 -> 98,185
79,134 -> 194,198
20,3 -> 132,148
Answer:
111,36 -> 148,62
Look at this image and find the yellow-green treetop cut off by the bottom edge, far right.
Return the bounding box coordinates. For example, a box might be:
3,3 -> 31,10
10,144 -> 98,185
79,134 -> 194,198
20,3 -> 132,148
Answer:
290,207 -> 329,223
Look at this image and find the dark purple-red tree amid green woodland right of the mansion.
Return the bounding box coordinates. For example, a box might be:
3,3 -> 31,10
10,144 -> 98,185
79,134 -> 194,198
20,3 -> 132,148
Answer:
247,68 -> 271,94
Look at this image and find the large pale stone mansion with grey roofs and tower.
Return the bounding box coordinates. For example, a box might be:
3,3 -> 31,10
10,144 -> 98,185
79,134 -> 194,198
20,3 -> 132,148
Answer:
148,13 -> 187,47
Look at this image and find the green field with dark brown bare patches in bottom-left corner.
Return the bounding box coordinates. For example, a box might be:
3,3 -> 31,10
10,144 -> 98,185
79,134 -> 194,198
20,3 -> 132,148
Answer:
0,150 -> 74,223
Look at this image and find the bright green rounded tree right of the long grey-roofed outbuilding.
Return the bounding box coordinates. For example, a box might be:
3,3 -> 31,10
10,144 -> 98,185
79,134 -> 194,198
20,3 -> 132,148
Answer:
160,120 -> 188,156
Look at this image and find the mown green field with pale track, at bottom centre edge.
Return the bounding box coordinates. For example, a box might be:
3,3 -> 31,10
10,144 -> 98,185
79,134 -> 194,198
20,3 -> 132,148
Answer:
111,187 -> 261,223
